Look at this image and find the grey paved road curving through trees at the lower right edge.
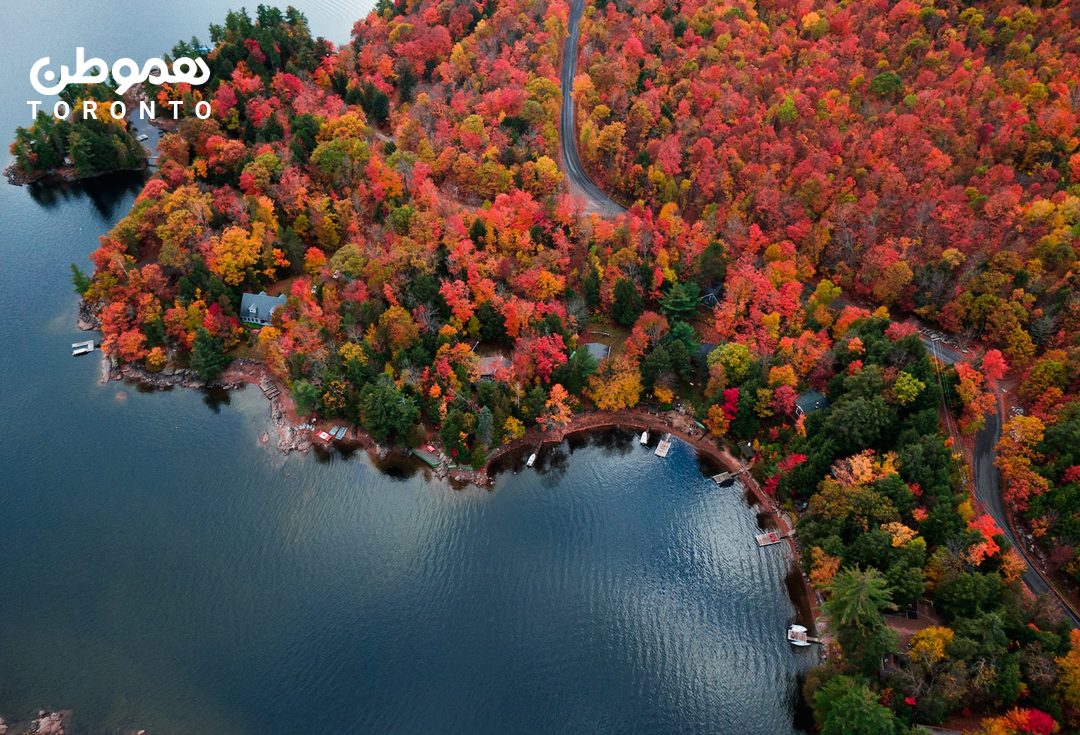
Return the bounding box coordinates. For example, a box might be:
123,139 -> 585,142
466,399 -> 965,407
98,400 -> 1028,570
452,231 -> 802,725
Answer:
922,337 -> 1080,628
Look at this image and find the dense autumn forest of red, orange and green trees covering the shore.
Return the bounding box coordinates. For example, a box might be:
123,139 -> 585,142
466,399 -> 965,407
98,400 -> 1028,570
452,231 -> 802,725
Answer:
35,0 -> 1080,735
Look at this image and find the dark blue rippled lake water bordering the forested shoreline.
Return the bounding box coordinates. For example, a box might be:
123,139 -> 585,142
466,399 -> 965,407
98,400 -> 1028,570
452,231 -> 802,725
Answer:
0,0 -> 814,735
